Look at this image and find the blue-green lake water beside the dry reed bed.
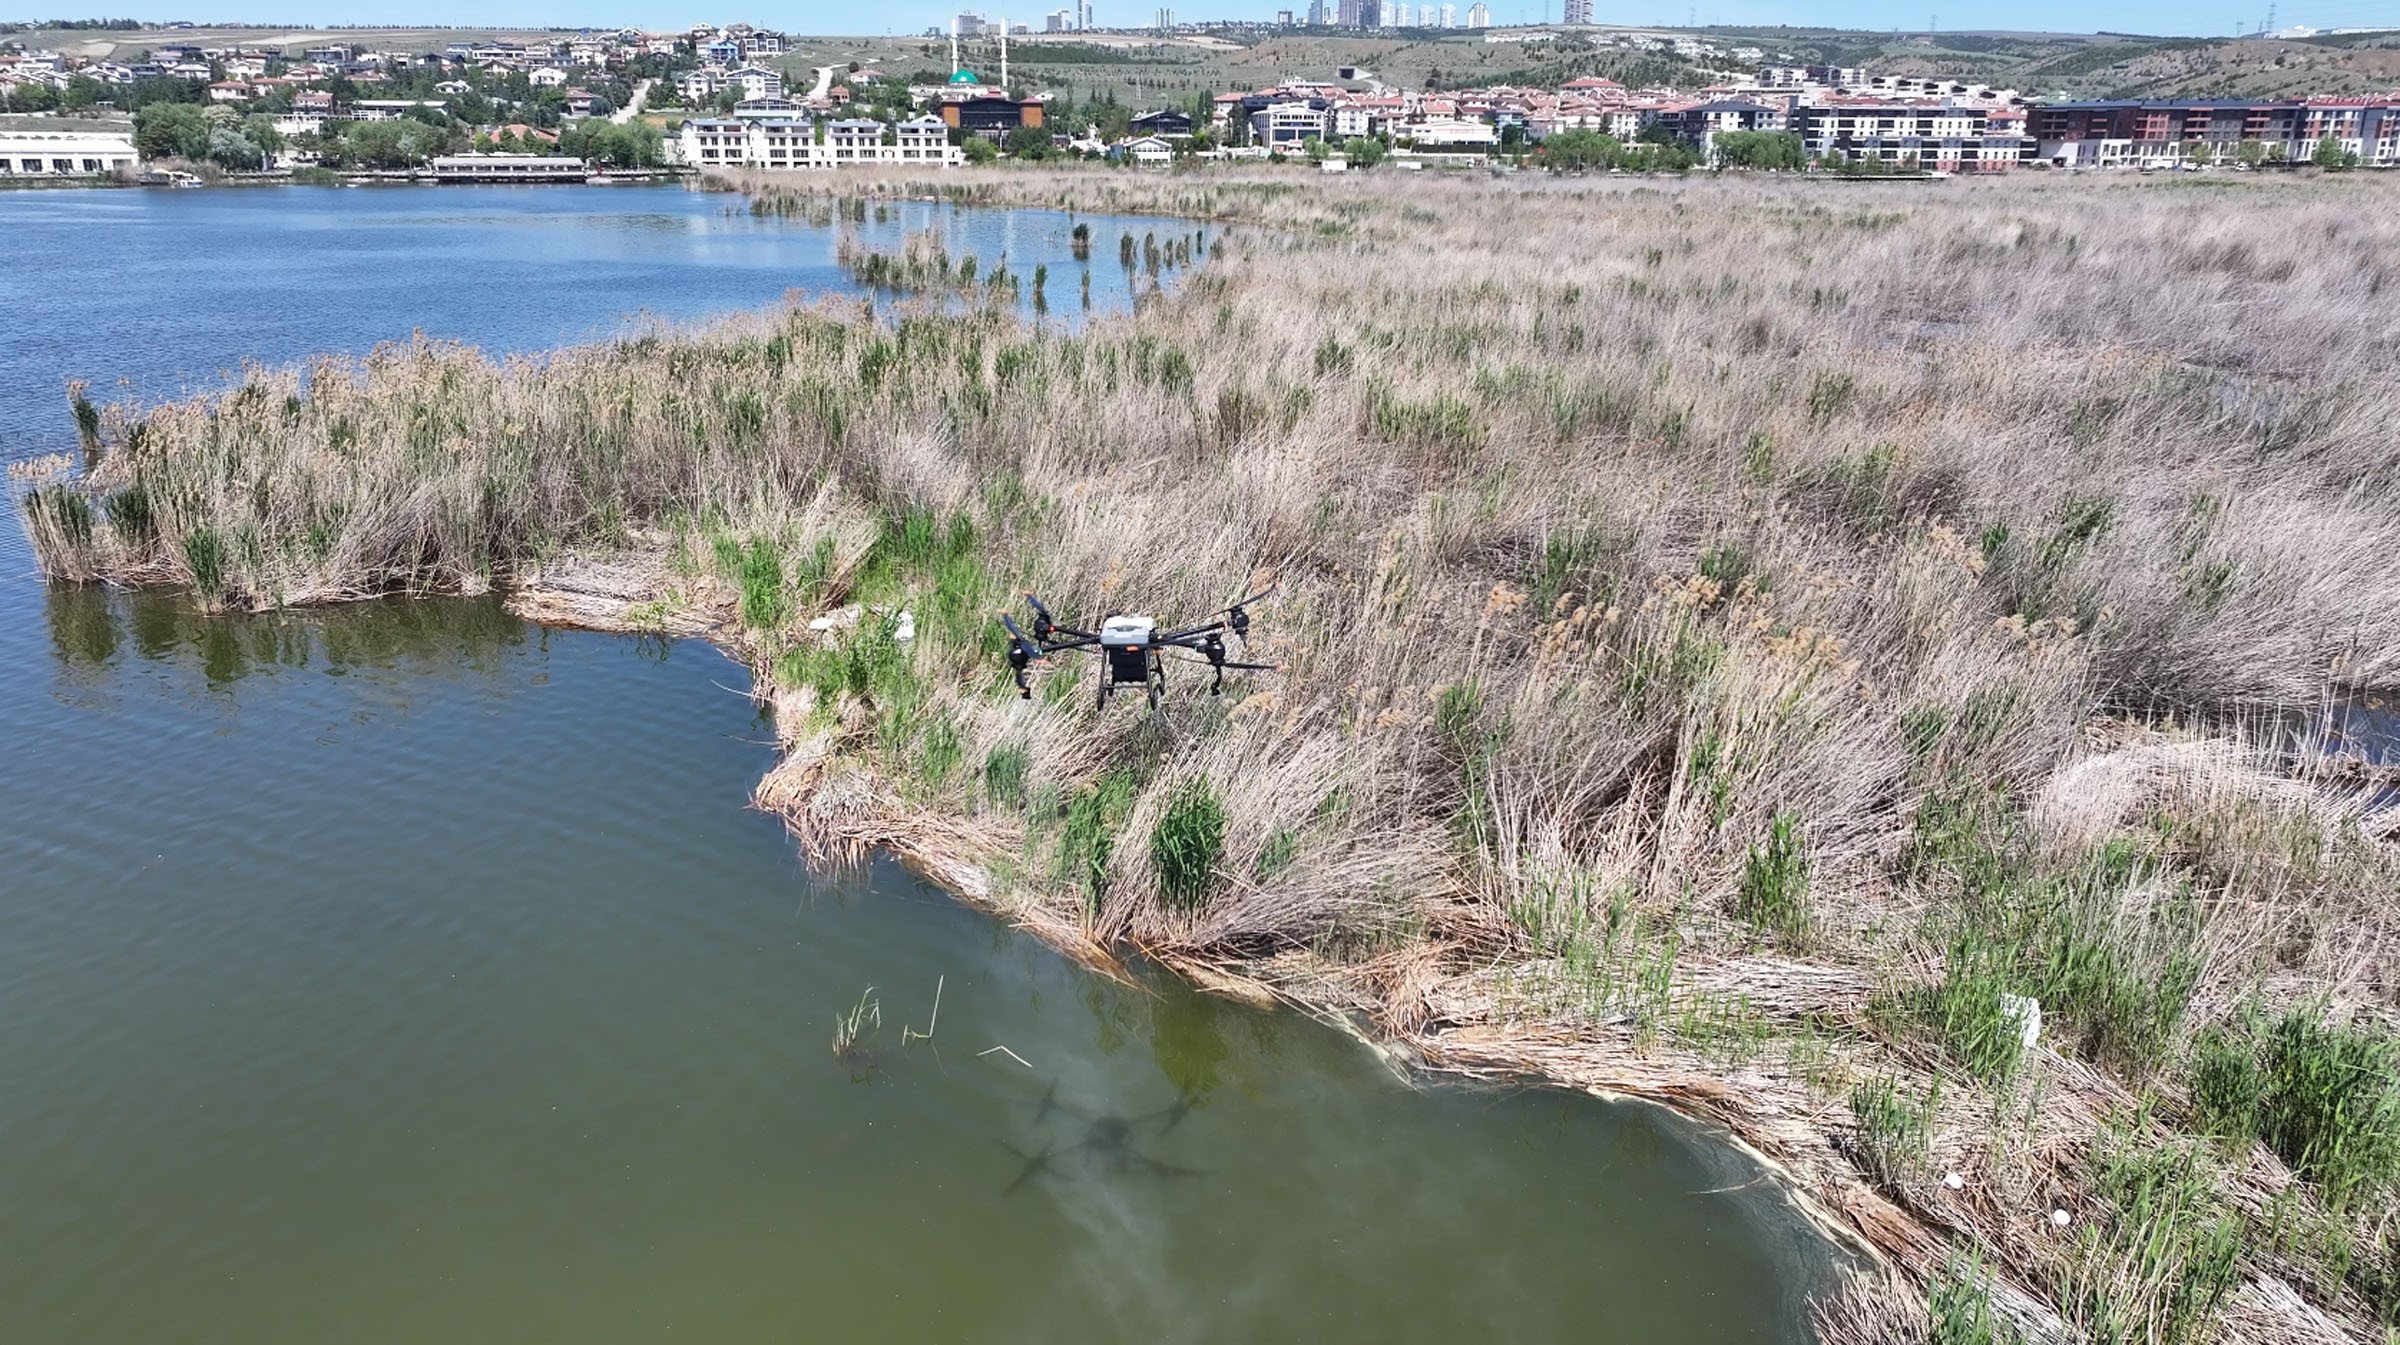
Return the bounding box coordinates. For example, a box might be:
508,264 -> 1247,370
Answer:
0,187 -> 1826,1345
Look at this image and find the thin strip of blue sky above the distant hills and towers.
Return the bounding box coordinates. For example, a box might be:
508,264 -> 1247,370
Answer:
131,0 -> 2400,34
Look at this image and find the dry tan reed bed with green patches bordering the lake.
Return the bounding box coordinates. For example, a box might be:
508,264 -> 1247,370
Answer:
24,171 -> 2400,1340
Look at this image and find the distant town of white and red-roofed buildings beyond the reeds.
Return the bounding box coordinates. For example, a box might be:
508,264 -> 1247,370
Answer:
0,21 -> 2400,180
